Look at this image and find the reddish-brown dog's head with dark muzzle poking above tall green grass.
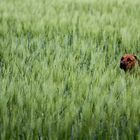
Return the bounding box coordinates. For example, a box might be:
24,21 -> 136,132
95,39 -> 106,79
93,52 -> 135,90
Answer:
120,54 -> 140,72
